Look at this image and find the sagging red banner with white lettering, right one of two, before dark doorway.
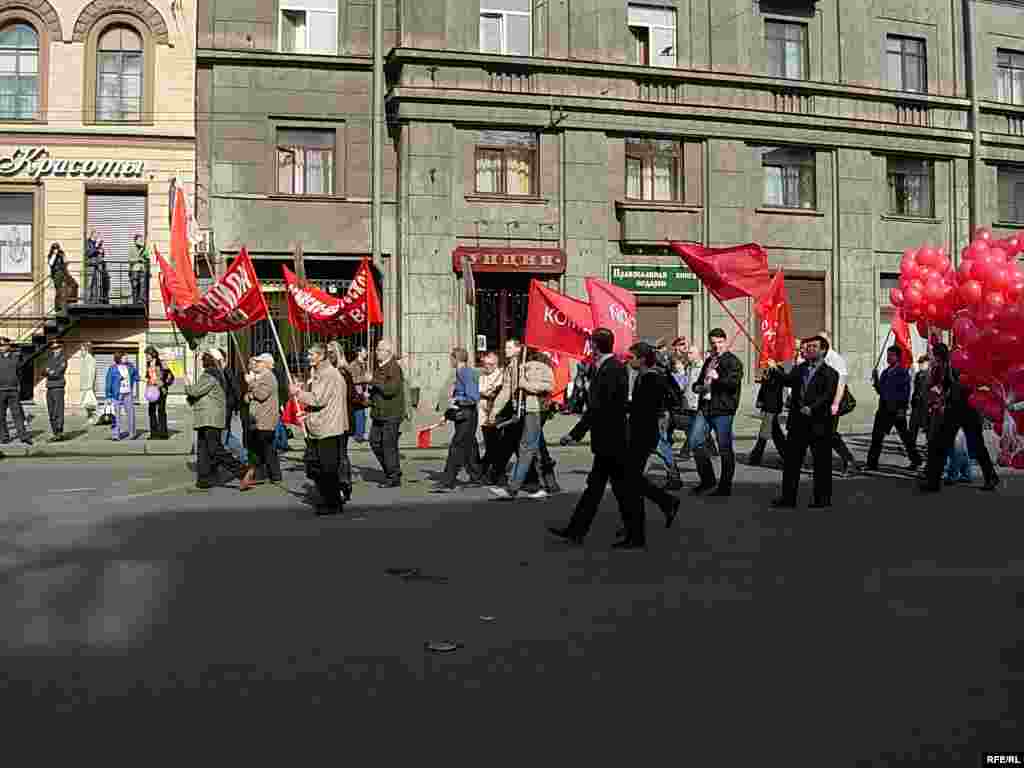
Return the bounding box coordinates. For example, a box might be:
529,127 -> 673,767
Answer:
281,259 -> 384,336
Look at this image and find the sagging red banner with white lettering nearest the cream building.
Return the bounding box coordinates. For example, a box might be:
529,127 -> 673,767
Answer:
161,248 -> 267,334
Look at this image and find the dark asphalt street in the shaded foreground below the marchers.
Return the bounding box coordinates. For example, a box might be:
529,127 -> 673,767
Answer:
0,444 -> 1024,767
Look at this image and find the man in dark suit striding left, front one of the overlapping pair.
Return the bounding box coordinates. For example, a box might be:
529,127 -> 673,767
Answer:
548,328 -> 644,550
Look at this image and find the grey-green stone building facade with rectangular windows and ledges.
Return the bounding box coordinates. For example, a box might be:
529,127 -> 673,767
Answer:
193,0 -> 1024,428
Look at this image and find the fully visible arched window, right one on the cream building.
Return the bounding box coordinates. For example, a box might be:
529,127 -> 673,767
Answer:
96,25 -> 144,122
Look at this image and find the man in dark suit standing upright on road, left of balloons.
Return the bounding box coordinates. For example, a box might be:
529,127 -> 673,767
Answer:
771,336 -> 839,509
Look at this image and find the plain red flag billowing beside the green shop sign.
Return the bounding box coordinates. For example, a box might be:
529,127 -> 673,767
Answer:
671,242 -> 771,301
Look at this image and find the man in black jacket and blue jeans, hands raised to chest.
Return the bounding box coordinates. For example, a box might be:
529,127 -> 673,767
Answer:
690,328 -> 743,496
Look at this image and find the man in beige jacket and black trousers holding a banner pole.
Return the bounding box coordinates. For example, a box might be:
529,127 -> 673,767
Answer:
291,344 -> 350,515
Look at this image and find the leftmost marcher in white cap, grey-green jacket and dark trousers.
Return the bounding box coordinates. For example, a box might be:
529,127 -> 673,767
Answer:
185,350 -> 251,490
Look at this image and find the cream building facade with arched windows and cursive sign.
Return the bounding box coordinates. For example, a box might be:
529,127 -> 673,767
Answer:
0,0 -> 196,402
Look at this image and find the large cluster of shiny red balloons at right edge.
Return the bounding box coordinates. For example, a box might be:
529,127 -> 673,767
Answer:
890,229 -> 1024,434
